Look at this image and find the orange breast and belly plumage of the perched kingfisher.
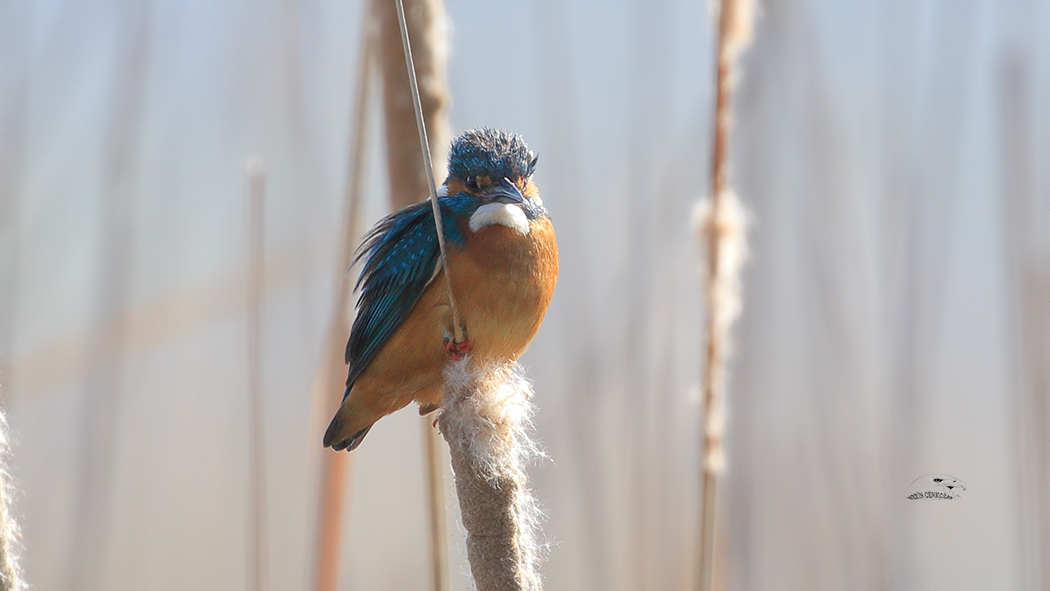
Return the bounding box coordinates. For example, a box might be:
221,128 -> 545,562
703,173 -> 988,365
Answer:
336,215 -> 558,440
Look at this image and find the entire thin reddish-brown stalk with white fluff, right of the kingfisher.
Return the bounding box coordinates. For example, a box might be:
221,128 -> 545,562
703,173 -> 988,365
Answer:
696,0 -> 754,591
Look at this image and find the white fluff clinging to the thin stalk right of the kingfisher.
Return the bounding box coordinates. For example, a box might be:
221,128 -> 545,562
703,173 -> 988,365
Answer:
693,191 -> 748,473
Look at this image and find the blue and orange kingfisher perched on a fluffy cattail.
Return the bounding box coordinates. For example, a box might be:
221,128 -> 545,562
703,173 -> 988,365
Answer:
324,128 -> 558,450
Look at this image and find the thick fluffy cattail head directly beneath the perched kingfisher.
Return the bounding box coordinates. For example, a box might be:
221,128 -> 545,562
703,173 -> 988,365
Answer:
438,358 -> 545,591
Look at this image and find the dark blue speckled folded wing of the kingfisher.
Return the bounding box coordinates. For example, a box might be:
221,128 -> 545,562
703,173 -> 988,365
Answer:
343,197 -> 463,398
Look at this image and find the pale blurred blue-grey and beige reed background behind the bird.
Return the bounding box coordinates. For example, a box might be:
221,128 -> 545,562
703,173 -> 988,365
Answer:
0,0 -> 1050,591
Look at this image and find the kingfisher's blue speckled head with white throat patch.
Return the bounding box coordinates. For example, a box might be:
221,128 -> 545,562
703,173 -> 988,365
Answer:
442,128 -> 547,234
